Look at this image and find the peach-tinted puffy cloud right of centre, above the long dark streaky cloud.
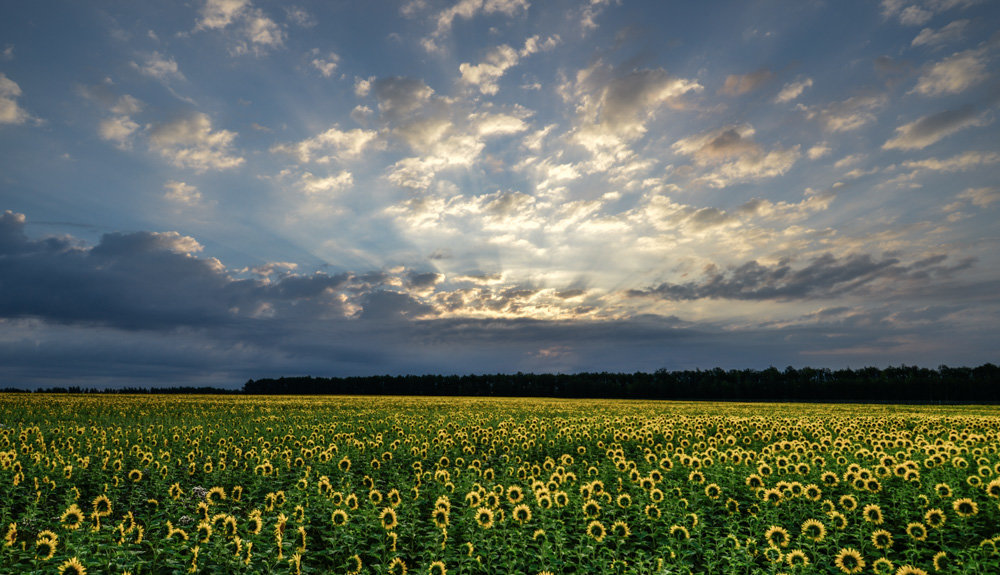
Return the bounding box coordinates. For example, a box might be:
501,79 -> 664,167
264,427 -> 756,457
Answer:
671,124 -> 801,188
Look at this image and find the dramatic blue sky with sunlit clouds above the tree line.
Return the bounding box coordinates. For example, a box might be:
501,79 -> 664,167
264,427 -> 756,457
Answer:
0,0 -> 1000,387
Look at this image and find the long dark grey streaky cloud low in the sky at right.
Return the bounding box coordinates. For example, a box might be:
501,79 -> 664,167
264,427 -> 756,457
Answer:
630,254 -> 974,301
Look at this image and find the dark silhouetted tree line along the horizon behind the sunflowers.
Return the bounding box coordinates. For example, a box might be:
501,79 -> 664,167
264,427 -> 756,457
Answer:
4,363 -> 1000,403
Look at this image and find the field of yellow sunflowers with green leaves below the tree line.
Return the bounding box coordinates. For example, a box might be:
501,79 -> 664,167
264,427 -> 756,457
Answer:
0,394 -> 1000,575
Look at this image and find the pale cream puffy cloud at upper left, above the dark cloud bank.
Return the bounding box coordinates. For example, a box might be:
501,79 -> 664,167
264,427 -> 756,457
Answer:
148,112 -> 244,173
